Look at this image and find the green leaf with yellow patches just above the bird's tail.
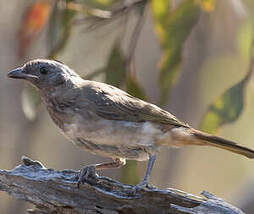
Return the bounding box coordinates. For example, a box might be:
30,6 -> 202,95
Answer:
200,73 -> 250,134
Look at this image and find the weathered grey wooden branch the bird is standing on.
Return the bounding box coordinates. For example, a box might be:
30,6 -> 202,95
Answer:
0,157 -> 243,214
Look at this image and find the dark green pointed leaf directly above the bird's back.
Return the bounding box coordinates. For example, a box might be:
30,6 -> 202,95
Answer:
104,42 -> 126,87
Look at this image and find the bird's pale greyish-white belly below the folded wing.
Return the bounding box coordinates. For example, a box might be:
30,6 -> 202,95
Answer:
64,120 -> 161,160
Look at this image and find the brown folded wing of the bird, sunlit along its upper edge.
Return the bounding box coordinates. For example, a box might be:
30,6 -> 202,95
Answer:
67,81 -> 189,127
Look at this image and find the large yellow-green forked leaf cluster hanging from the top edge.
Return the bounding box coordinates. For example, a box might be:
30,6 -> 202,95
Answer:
151,0 -> 200,105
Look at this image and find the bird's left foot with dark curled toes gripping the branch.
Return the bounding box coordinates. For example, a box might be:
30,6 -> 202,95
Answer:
77,165 -> 98,188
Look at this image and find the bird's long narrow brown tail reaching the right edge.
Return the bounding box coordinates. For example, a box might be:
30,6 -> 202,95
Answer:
193,131 -> 254,158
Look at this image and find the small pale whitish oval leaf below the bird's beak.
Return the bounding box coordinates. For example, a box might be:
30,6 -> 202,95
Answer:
21,85 -> 41,120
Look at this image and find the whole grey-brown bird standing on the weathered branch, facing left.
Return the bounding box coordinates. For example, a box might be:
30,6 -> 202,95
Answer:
7,59 -> 254,187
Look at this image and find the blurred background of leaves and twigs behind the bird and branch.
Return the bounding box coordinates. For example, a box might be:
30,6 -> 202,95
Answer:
0,0 -> 254,214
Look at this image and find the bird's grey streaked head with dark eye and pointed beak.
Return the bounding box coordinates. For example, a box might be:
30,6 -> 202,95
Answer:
8,59 -> 79,90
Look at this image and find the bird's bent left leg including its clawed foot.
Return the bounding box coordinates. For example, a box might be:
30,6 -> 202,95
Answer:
77,158 -> 126,188
